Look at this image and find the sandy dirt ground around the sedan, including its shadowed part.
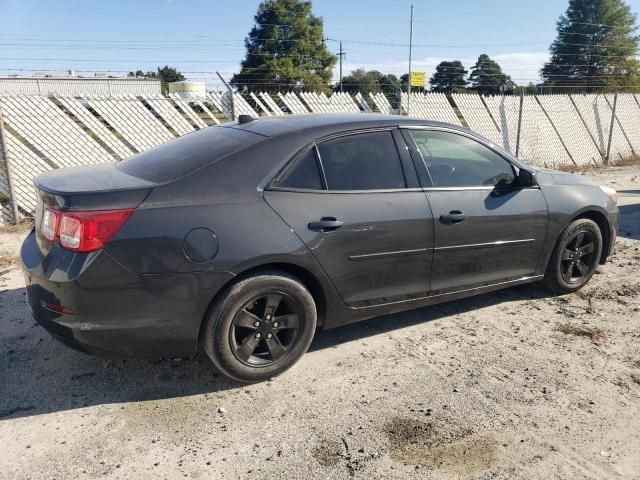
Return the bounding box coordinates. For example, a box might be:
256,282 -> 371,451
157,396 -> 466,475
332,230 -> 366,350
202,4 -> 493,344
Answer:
0,167 -> 640,479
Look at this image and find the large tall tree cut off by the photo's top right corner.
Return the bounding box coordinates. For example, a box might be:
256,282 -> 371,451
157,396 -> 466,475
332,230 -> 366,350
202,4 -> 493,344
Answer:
541,0 -> 639,92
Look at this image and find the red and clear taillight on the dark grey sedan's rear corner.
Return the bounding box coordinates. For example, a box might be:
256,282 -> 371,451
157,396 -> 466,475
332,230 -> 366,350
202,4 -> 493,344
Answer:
42,209 -> 133,252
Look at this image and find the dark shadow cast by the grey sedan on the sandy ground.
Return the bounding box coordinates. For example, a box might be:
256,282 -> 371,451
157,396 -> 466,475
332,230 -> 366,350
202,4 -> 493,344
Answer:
0,286 -> 548,421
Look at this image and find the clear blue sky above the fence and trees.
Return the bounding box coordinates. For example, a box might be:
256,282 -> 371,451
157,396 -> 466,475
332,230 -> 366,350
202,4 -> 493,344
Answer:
0,0 -> 640,88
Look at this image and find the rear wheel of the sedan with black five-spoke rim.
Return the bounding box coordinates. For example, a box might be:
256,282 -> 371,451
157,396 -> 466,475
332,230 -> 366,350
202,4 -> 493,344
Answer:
203,272 -> 317,383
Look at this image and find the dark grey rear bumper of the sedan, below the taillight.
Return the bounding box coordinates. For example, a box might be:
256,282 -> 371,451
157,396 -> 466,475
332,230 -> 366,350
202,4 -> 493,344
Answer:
21,232 -> 233,358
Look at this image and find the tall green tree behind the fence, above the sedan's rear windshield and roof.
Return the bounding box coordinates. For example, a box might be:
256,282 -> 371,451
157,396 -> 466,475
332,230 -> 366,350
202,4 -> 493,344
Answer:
231,0 -> 336,92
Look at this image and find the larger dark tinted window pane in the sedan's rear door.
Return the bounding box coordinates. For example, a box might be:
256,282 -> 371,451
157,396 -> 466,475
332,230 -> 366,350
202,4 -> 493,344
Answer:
318,131 -> 407,190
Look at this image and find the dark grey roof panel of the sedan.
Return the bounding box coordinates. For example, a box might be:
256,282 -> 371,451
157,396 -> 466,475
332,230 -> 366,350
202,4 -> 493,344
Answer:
224,113 -> 461,137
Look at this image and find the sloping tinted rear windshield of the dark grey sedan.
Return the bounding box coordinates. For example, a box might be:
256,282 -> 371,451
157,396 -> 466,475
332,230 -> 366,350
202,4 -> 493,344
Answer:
117,126 -> 265,183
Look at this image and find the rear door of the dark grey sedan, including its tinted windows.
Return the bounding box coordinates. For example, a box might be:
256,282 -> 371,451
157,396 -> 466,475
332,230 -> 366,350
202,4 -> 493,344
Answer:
264,129 -> 433,306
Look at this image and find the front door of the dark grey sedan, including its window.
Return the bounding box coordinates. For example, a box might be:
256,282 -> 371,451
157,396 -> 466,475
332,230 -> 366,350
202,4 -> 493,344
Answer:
405,129 -> 548,294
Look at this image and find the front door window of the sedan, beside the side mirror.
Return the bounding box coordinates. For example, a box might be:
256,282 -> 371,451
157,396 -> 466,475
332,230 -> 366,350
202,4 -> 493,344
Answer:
410,130 -> 515,188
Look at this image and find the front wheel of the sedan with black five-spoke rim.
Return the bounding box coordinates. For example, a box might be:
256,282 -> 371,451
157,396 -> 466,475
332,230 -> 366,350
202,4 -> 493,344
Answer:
542,218 -> 602,294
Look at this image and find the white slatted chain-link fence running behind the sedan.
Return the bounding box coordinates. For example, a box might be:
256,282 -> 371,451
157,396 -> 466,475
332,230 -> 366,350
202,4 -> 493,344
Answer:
0,91 -> 640,223
